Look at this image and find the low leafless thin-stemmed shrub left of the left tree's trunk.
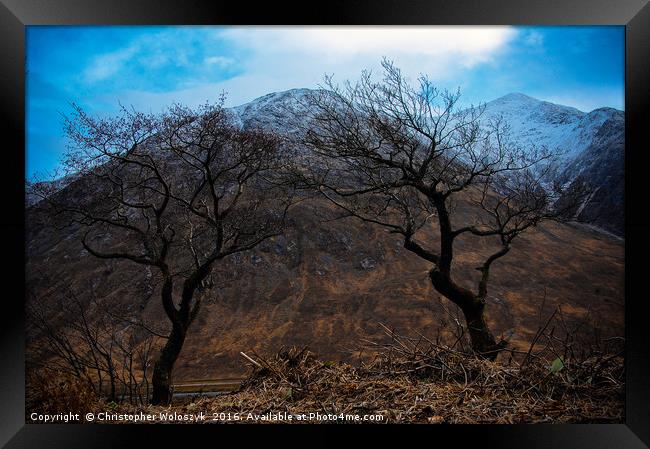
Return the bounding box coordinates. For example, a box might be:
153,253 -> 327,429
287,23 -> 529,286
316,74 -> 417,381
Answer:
27,289 -> 161,404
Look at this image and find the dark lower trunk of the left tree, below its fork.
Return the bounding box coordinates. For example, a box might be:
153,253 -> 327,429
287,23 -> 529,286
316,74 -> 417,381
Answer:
151,324 -> 187,405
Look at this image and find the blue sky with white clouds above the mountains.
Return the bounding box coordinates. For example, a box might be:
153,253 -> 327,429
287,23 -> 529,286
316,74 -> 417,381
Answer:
26,26 -> 624,178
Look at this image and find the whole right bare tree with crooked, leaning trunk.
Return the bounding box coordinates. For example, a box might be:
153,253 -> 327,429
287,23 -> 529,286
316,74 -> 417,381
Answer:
296,60 -> 580,358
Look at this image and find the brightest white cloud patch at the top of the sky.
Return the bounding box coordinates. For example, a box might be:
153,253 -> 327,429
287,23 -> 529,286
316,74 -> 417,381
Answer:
221,26 -> 516,77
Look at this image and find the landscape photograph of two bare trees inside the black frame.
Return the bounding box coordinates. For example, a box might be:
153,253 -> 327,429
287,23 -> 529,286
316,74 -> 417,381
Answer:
24,25 -> 630,425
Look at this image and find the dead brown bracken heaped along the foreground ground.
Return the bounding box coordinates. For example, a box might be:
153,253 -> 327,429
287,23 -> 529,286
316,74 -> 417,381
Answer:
93,322 -> 624,424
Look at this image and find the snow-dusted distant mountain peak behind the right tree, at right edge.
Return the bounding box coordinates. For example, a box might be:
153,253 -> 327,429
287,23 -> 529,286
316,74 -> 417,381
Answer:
484,93 -> 625,236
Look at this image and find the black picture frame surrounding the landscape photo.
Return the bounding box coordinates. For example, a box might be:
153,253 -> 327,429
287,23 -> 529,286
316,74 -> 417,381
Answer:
0,0 -> 650,449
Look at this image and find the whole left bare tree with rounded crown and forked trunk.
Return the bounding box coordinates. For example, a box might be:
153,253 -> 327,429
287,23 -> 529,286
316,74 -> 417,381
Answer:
33,100 -> 292,404
